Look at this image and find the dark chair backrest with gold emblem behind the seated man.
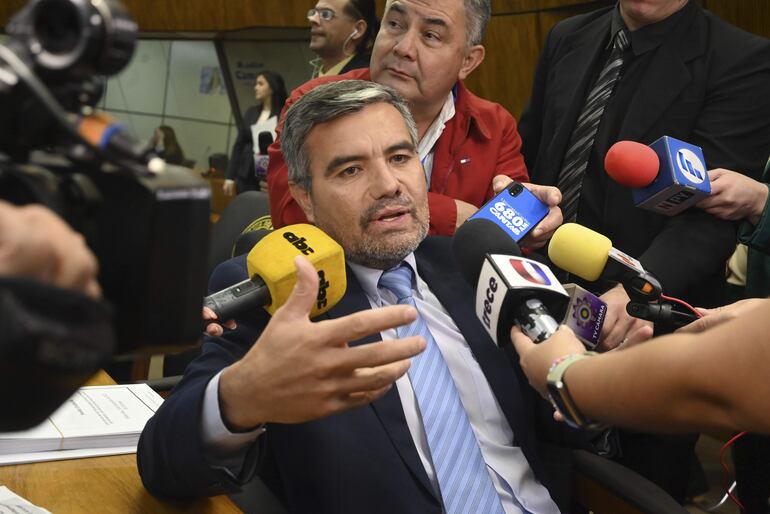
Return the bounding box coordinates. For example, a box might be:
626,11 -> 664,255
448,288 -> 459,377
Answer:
209,191 -> 273,274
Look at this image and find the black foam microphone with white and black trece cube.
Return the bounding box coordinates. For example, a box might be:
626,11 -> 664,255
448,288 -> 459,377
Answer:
452,219 -> 569,346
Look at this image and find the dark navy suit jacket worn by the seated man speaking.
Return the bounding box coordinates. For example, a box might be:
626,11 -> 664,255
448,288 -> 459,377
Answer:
137,237 -> 570,514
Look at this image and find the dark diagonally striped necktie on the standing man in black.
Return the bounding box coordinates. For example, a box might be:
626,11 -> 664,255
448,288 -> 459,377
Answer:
556,29 -> 629,223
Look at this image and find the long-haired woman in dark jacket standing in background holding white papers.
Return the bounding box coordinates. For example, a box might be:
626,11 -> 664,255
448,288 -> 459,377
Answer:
222,70 -> 287,196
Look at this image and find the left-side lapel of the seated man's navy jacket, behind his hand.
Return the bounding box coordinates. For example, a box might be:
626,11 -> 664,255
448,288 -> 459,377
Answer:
326,268 -> 441,503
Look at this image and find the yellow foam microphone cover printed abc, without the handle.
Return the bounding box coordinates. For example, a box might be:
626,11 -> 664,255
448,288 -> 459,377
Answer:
246,223 -> 347,317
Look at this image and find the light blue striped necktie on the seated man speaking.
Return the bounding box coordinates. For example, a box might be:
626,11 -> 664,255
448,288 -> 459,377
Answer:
379,264 -> 504,514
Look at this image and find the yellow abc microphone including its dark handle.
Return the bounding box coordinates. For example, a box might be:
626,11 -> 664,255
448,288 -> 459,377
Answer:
203,223 -> 347,320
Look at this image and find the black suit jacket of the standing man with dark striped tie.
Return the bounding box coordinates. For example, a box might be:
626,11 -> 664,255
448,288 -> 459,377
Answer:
519,0 -> 770,305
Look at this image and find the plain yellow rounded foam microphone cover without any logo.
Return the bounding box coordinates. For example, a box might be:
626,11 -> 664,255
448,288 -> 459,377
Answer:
548,223 -> 612,281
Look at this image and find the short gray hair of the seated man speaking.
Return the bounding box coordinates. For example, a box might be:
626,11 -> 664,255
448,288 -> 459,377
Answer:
281,80 -> 417,191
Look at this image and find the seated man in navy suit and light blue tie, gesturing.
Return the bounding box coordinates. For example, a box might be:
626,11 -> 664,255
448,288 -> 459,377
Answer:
138,81 -> 569,514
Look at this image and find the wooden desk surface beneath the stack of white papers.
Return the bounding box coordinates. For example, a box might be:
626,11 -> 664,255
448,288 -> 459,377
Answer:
0,372 -> 241,514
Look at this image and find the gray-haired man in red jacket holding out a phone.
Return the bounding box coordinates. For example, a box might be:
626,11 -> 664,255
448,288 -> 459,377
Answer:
268,0 -> 561,240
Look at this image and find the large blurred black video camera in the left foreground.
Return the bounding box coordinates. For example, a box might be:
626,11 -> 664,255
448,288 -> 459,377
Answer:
0,0 -> 210,424
